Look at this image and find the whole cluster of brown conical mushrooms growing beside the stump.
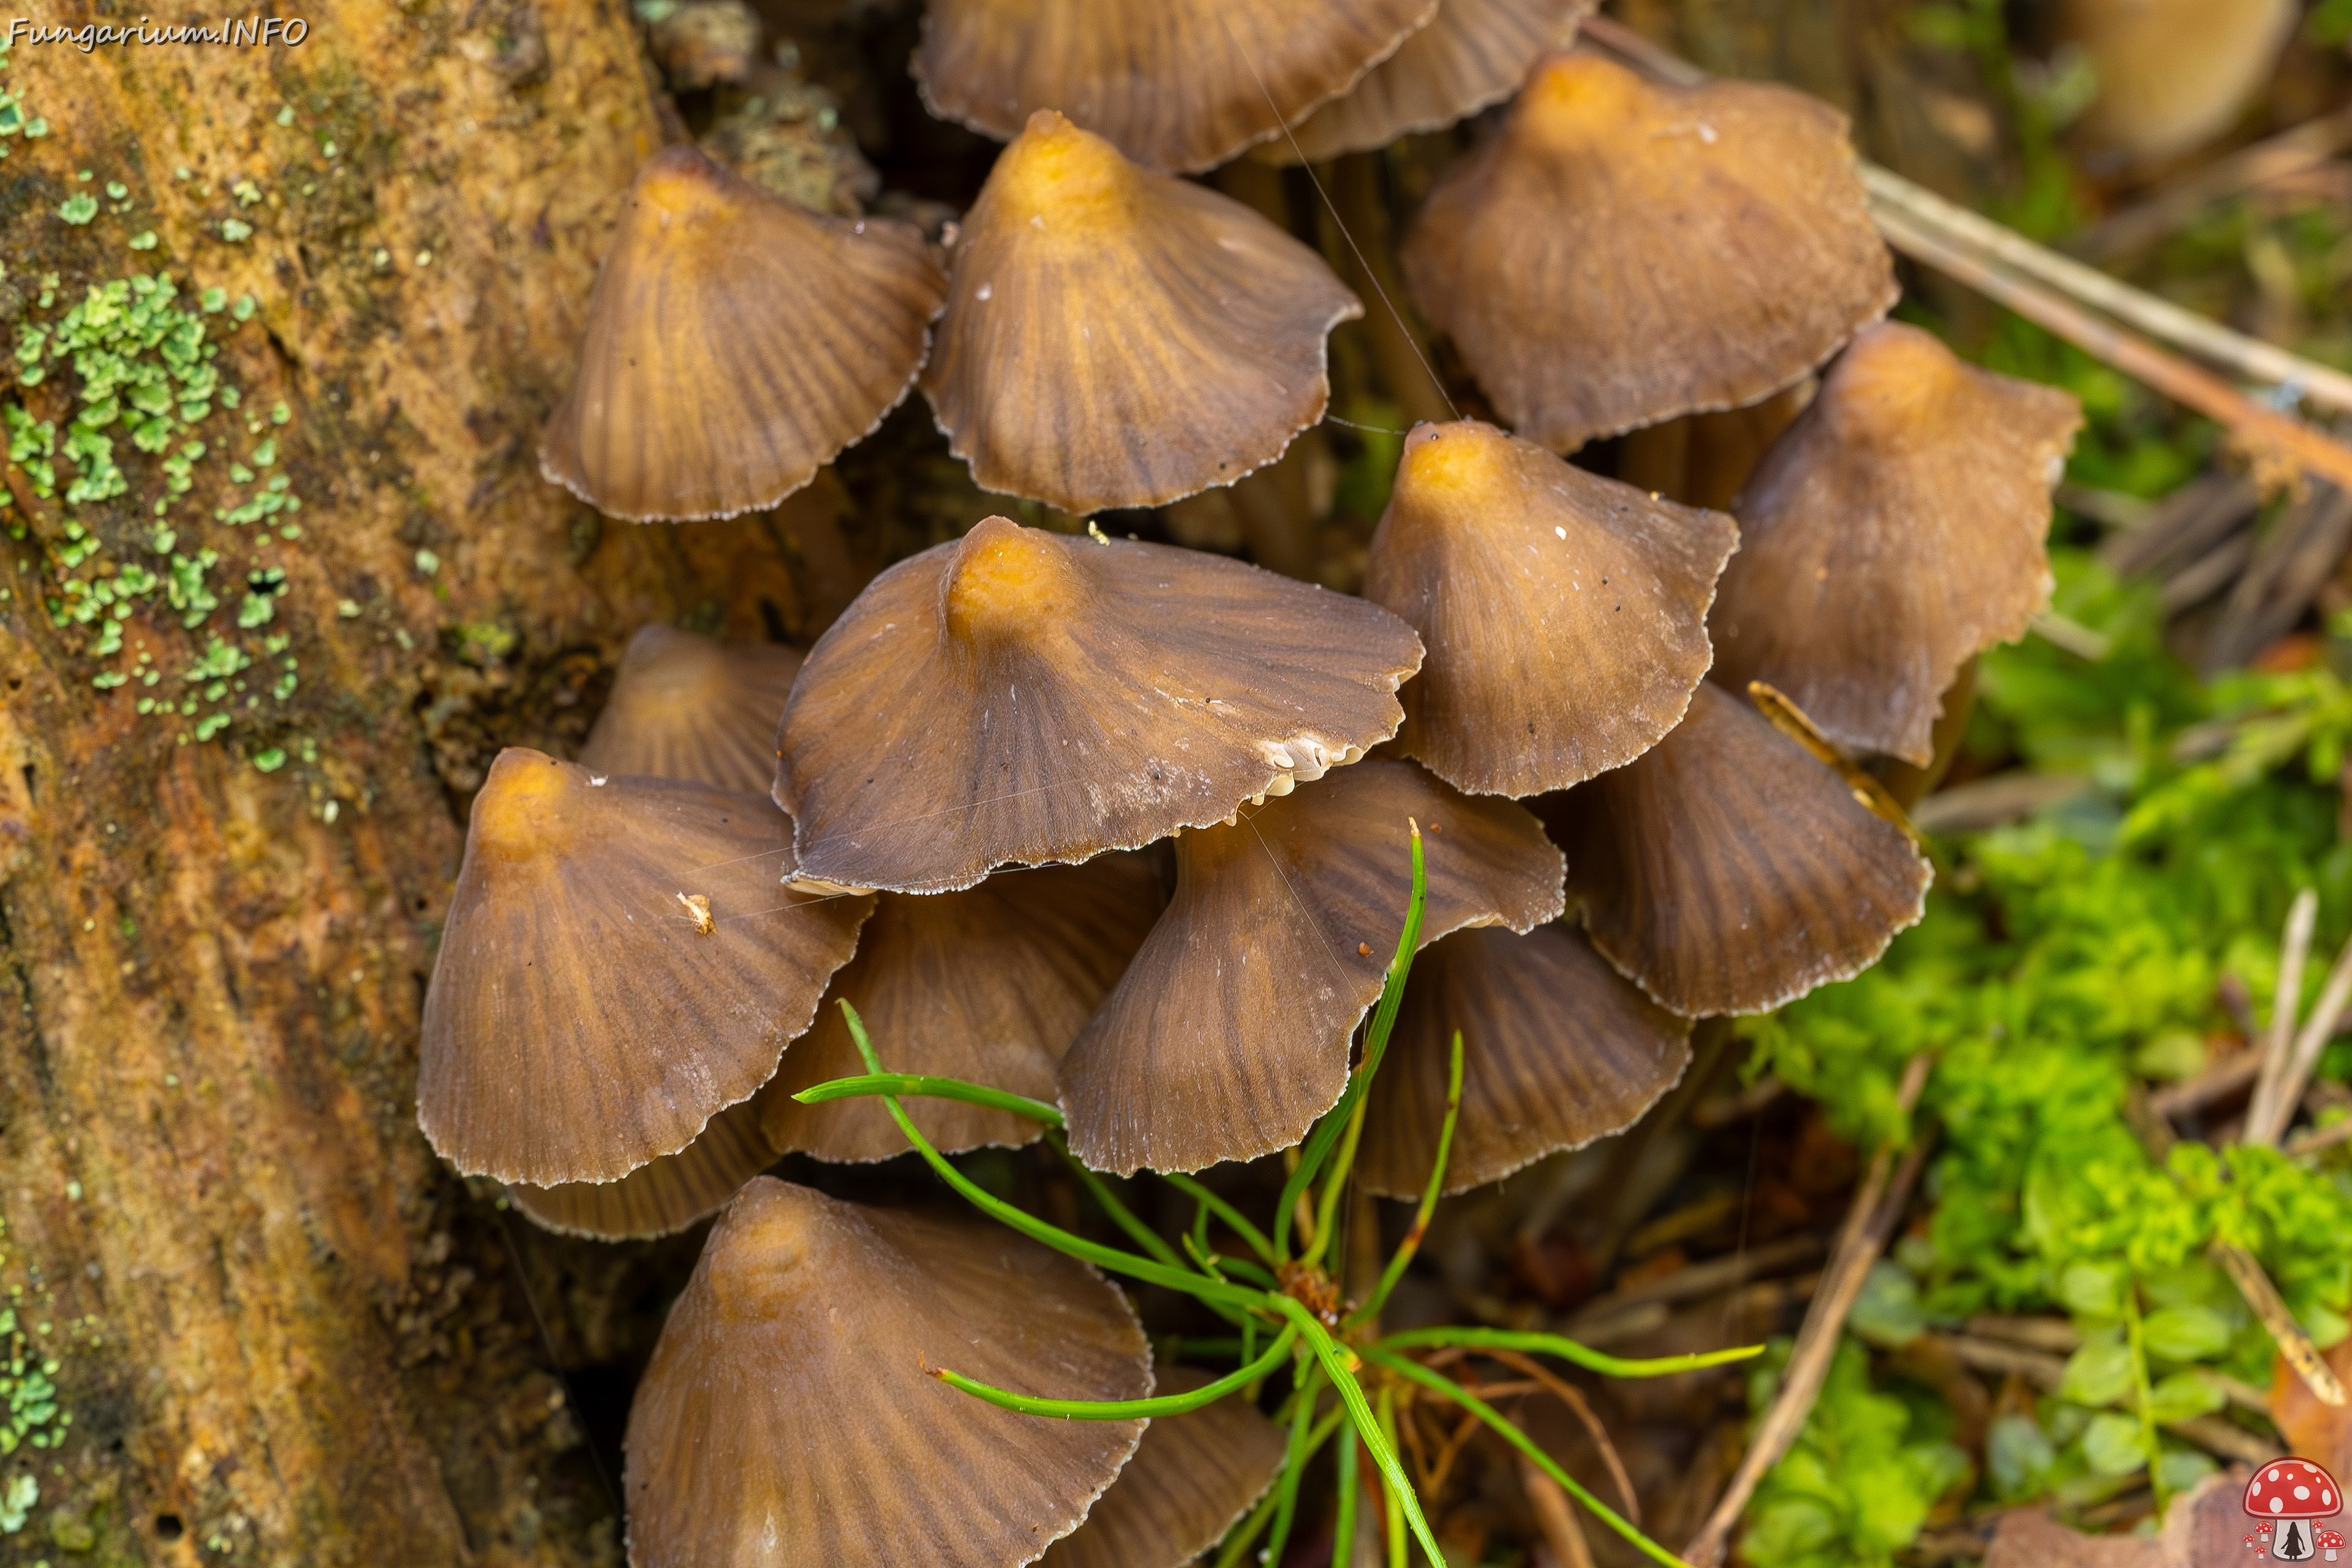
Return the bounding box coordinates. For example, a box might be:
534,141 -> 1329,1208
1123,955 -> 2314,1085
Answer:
419,0 -> 2079,1568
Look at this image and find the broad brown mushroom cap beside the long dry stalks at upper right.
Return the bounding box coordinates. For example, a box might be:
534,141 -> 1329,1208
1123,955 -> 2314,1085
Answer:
1402,54 -> 1896,451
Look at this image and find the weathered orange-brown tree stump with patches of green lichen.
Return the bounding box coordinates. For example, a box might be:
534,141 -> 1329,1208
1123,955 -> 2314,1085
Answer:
0,0 -> 854,1568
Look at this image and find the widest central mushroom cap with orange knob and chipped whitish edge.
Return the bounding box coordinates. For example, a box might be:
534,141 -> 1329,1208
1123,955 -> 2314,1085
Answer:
776,517 -> 1420,893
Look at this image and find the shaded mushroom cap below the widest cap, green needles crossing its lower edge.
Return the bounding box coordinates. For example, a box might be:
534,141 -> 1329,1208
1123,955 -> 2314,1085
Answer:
767,856 -> 1164,1159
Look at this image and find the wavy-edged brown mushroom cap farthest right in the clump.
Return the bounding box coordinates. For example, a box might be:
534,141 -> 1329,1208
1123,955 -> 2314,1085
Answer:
1712,322 -> 2081,766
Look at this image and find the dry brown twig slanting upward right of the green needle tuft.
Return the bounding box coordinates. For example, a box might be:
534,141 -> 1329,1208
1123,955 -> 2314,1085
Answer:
1682,1051 -> 1933,1568
